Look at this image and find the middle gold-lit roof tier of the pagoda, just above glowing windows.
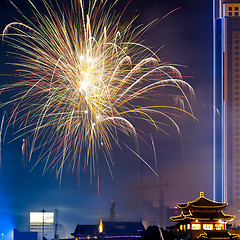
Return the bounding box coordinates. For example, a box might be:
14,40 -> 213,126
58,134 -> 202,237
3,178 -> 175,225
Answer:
170,211 -> 235,222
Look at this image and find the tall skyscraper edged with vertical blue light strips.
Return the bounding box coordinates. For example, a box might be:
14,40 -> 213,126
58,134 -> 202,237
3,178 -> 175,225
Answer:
213,0 -> 240,208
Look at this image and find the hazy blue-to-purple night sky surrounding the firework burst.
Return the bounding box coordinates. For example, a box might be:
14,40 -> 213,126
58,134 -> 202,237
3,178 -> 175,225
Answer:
0,0 -> 212,239
